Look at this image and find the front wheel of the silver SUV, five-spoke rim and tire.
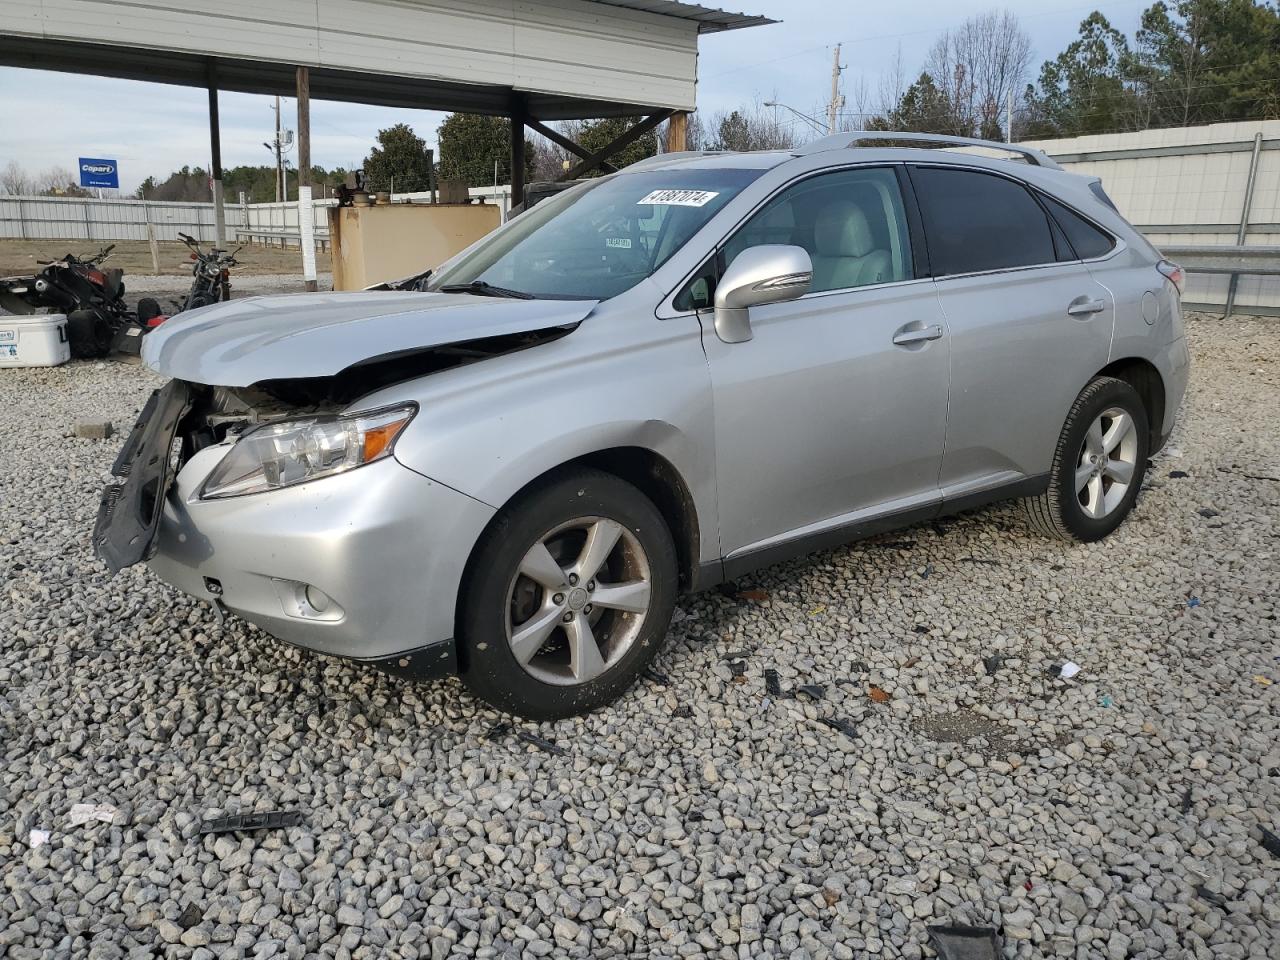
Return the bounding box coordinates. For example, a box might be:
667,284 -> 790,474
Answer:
458,470 -> 677,719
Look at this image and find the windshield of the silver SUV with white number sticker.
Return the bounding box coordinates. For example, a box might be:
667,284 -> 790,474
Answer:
429,169 -> 764,300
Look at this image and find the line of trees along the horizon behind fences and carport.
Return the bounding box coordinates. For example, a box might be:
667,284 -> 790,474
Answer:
0,0 -> 1280,202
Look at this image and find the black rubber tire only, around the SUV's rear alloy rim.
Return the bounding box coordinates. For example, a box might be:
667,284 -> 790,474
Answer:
1023,376 -> 1151,543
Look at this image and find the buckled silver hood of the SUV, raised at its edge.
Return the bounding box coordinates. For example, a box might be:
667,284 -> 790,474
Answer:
142,291 -> 599,387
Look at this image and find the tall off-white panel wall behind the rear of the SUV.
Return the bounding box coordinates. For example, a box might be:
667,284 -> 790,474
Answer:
1028,120 -> 1280,312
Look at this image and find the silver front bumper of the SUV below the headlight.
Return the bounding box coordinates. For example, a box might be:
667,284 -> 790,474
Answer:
150,447 -> 494,676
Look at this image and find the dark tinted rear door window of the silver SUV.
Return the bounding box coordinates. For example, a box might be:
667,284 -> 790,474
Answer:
911,166 -> 1057,276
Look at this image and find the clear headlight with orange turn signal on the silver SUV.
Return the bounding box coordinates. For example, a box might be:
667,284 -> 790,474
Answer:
200,403 -> 417,500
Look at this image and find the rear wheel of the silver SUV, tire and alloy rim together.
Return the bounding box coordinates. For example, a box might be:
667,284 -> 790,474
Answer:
1024,376 -> 1149,543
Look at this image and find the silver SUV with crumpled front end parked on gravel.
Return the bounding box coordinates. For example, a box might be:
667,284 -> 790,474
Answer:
95,134 -> 1188,718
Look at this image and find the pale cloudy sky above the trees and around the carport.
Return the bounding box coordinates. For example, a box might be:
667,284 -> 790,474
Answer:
0,0 -> 1151,191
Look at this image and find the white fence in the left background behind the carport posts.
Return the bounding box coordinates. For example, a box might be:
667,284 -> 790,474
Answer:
0,184 -> 511,246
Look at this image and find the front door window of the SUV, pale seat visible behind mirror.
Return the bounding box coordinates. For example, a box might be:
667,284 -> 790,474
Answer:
673,168 -> 914,310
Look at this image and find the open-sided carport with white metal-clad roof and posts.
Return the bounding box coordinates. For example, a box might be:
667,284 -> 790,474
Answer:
0,0 -> 773,287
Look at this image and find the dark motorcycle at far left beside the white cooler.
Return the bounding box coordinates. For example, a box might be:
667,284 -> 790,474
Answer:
0,243 -> 138,358
